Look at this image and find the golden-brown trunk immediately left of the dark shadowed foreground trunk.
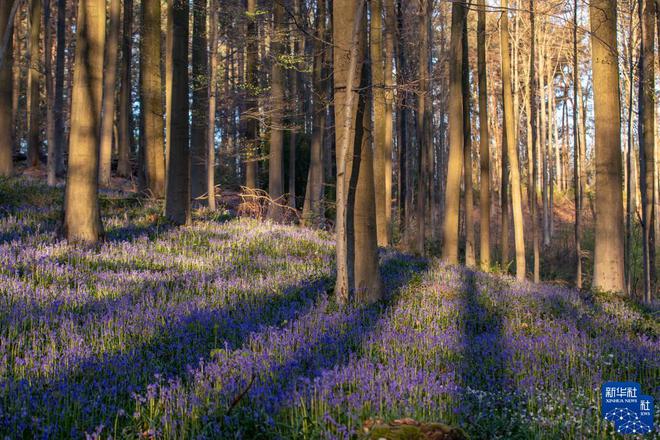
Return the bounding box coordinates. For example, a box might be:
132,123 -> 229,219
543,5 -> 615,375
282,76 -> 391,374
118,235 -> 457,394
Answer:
140,0 -> 166,198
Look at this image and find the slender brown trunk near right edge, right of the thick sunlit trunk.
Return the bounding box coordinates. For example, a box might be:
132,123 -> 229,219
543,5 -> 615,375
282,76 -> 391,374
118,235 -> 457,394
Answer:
639,0 -> 656,303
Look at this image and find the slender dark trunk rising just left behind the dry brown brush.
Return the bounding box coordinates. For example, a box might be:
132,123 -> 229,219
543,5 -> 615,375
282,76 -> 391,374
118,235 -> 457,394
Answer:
245,0 -> 259,188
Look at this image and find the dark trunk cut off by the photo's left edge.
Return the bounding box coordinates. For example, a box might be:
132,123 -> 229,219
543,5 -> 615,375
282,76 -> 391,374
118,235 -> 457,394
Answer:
0,0 -> 14,177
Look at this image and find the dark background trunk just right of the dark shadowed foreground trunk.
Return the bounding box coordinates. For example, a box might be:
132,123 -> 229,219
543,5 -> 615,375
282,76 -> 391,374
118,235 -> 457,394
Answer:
190,0 -> 209,204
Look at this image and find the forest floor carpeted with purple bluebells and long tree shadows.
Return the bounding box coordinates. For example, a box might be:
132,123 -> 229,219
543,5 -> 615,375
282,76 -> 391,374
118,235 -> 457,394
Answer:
0,178 -> 660,439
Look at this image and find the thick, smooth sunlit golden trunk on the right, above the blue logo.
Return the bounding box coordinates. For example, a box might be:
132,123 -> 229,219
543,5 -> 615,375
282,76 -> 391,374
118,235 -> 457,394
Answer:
589,0 -> 624,292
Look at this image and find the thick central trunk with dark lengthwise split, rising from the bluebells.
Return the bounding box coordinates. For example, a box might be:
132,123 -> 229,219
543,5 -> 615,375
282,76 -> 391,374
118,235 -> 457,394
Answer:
333,0 -> 382,303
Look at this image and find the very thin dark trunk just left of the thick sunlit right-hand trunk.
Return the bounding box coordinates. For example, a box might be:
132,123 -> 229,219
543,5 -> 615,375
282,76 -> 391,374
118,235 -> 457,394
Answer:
573,0 -> 582,289
